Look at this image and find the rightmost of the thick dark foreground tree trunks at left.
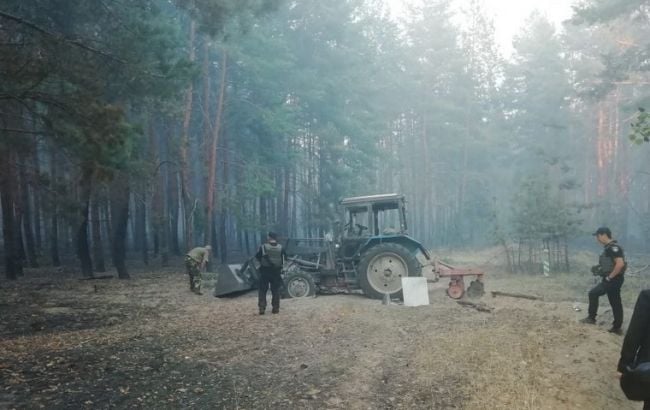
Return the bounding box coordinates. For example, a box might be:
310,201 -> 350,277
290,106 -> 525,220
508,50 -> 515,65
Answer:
111,175 -> 130,279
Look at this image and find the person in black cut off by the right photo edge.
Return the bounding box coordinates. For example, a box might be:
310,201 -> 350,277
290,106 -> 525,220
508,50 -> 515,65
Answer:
618,289 -> 650,410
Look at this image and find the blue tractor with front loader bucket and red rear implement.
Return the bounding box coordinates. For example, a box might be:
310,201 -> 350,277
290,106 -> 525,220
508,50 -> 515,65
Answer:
214,194 -> 484,299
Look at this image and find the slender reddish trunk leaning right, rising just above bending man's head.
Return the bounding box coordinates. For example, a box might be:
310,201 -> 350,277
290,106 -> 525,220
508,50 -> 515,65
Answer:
205,48 -> 228,249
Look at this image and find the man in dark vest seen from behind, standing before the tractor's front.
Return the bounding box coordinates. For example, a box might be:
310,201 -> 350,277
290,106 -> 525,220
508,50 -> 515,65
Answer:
255,232 -> 286,315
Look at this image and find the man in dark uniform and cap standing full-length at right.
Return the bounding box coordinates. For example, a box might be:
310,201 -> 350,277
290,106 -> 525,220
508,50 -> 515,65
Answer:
581,227 -> 627,335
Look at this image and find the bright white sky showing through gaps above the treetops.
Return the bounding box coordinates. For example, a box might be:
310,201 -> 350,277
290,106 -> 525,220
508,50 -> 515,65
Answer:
386,0 -> 573,55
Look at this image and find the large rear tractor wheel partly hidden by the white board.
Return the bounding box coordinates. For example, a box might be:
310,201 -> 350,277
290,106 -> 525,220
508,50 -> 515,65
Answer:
357,242 -> 422,299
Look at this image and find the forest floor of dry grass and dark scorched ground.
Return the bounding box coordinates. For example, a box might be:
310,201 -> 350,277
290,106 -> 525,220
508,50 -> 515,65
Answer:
0,248 -> 648,410
